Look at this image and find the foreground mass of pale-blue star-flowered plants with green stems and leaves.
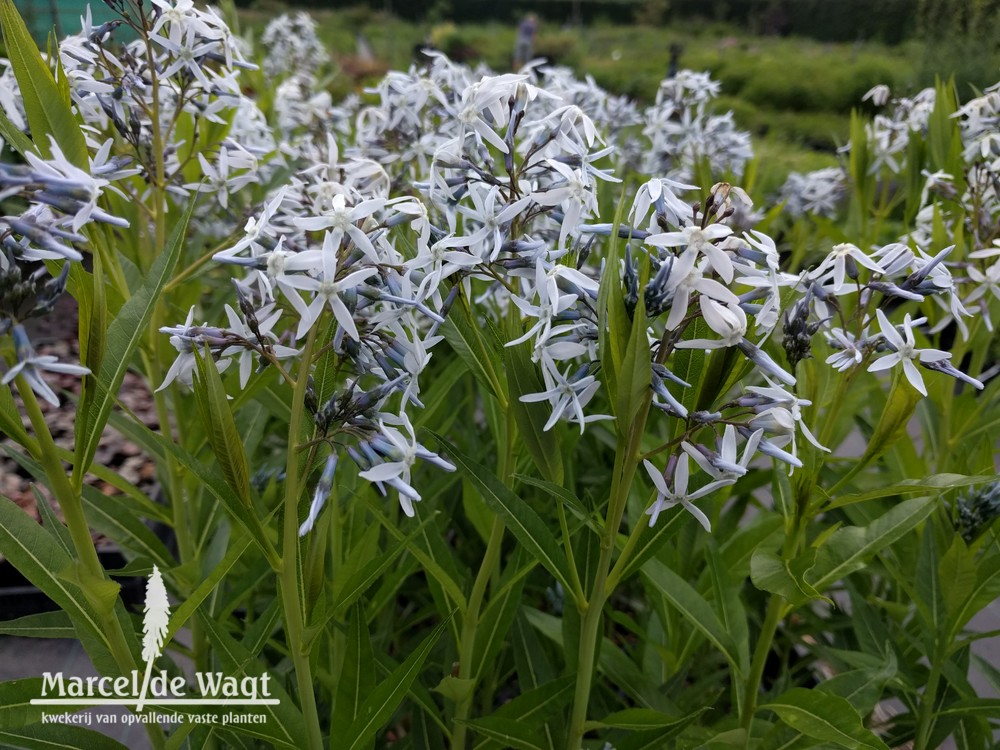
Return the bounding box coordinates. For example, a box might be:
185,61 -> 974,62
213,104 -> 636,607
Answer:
0,0 -> 1000,750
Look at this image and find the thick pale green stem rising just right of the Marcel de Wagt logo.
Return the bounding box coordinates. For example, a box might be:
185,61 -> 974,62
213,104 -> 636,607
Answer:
278,325 -> 323,750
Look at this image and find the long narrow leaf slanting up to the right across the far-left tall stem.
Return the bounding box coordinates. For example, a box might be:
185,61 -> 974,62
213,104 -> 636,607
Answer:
75,194 -> 195,477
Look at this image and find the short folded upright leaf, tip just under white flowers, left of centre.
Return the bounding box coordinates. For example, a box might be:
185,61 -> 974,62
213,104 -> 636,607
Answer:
191,346 -> 254,513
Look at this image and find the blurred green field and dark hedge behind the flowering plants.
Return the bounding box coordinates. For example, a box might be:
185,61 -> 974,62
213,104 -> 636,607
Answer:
229,0 -> 1000,194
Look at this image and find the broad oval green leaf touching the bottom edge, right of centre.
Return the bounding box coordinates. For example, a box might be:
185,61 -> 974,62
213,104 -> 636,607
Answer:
760,688 -> 889,750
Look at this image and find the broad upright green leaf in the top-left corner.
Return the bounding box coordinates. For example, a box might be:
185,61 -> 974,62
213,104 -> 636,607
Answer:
0,0 -> 88,168
